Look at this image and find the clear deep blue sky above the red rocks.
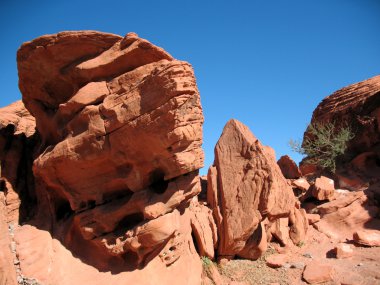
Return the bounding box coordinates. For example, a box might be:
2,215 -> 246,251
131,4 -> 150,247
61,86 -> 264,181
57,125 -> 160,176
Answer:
0,0 -> 380,174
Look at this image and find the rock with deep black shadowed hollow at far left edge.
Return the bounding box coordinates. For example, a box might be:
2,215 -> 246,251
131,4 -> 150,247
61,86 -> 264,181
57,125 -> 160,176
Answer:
0,101 -> 38,223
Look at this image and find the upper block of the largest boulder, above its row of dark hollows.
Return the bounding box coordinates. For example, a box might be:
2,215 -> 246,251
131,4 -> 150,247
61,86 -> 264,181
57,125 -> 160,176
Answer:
18,32 -> 203,211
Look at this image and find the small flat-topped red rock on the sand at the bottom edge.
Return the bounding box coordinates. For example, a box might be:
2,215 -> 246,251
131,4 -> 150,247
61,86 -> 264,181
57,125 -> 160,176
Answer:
302,261 -> 334,284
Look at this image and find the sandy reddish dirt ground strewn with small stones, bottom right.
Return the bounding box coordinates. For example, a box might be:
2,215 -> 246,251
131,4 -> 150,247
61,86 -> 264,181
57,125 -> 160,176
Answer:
218,226 -> 380,285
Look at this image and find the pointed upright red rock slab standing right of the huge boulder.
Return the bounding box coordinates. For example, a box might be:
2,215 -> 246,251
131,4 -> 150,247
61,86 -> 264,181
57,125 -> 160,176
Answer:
207,120 -> 307,259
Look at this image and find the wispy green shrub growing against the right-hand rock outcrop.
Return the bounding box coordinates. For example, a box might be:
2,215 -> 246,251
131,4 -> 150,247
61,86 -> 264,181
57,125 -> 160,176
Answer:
289,123 -> 354,172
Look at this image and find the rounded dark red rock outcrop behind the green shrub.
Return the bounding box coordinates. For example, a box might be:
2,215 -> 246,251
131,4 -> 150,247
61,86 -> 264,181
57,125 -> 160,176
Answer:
301,76 -> 380,181
